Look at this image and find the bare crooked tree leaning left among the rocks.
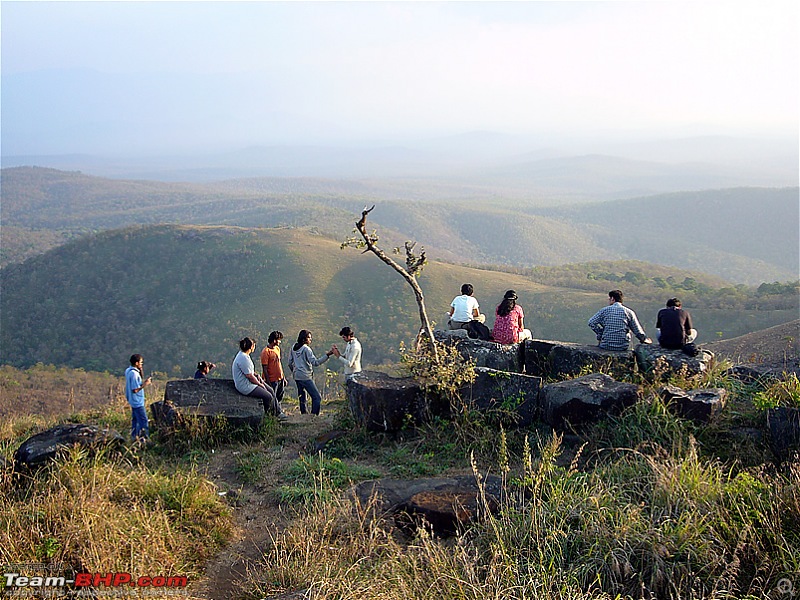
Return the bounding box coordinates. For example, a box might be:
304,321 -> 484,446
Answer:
341,204 -> 438,362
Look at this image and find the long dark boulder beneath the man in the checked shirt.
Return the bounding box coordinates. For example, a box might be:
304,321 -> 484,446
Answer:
524,340 -> 635,379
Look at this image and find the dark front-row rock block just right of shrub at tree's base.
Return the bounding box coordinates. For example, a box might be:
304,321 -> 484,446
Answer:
459,367 -> 542,427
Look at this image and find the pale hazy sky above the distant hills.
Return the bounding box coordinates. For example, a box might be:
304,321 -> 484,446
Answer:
0,0 -> 800,155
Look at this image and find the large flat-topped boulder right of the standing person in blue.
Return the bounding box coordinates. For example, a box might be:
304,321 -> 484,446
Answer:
155,379 -> 264,429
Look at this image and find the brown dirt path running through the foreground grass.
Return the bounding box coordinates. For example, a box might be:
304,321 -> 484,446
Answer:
193,405 -> 336,600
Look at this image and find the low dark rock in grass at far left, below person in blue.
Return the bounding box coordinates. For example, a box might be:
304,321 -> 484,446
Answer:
14,423 -> 125,467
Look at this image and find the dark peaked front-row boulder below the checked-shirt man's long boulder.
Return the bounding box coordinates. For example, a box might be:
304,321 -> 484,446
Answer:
539,373 -> 641,429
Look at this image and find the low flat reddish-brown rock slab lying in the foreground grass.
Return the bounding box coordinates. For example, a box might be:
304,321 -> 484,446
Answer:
353,475 -> 502,537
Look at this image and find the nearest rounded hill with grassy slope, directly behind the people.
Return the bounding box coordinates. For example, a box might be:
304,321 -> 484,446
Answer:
0,225 -> 797,376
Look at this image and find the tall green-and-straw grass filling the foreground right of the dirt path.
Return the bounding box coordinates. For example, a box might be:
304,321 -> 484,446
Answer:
243,422 -> 800,600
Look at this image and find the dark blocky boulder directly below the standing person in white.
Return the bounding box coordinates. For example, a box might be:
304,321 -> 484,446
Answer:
345,371 -> 430,431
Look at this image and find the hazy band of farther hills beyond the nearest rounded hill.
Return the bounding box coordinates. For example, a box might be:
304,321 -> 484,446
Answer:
0,167 -> 800,284
